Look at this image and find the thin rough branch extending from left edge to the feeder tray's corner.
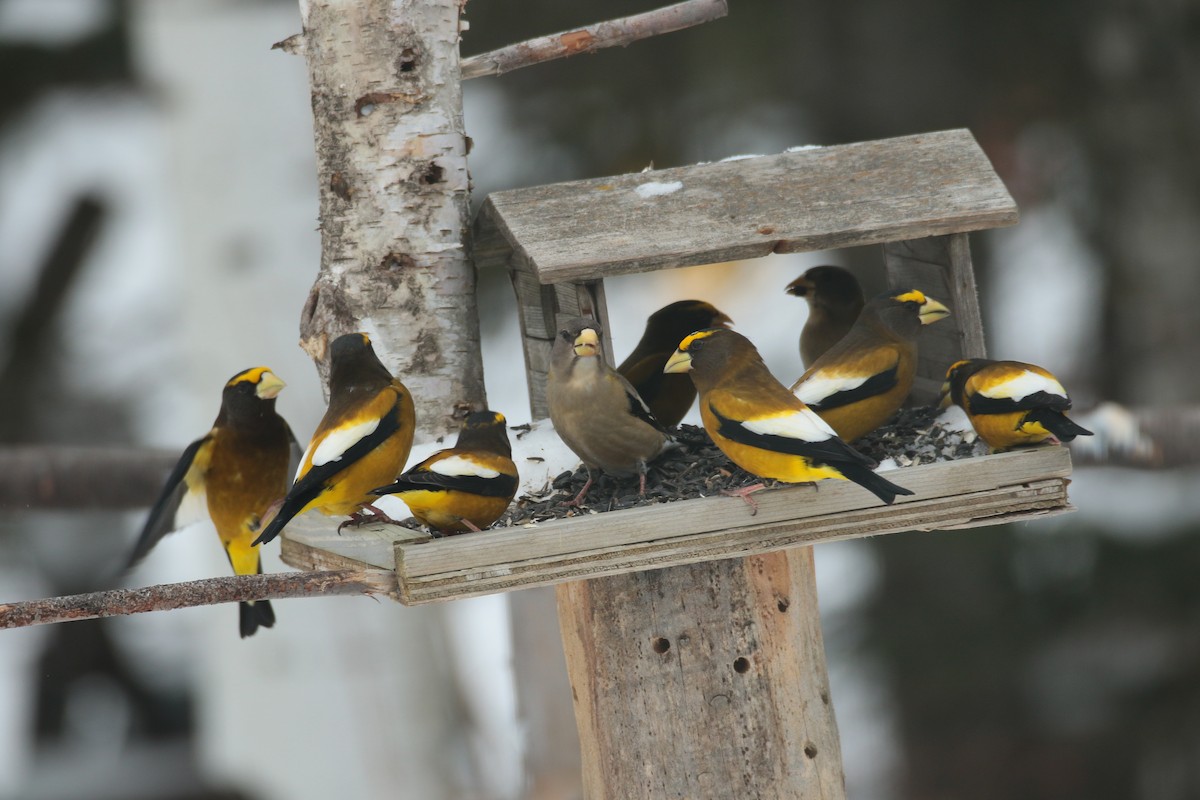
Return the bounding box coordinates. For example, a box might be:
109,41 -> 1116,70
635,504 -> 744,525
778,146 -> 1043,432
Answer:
0,570 -> 396,628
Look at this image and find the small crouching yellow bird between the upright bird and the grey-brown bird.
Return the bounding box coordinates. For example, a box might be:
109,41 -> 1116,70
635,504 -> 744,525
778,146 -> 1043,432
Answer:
371,410 -> 517,534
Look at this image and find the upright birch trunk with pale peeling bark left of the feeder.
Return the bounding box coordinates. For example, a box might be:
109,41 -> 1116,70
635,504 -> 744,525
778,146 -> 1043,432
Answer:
300,0 -> 485,438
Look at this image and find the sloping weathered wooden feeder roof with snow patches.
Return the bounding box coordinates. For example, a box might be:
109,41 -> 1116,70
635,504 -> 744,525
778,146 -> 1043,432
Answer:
475,130 -> 1016,284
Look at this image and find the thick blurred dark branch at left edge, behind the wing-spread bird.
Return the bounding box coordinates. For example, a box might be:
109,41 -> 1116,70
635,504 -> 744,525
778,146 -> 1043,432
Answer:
0,445 -> 179,511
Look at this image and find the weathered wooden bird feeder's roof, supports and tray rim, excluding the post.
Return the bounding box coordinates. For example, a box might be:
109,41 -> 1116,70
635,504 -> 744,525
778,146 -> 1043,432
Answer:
283,130 -> 1070,604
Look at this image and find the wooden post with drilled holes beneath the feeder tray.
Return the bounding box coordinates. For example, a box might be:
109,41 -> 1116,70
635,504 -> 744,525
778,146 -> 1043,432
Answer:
558,547 -> 846,800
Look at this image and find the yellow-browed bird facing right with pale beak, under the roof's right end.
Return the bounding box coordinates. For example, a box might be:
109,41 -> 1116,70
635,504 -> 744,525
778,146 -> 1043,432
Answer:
792,289 -> 950,441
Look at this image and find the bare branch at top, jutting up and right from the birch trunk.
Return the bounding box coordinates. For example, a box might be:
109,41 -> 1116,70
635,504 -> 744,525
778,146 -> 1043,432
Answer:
460,0 -> 730,80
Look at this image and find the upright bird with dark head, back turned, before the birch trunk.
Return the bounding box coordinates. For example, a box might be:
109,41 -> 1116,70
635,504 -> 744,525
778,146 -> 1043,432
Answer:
254,333 -> 416,545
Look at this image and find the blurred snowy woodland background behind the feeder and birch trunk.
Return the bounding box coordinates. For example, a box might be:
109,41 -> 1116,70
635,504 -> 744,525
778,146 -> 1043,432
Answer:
0,0 -> 1200,800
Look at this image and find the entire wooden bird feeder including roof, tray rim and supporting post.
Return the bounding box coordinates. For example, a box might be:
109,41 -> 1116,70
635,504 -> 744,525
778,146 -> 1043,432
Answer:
282,131 -> 1070,800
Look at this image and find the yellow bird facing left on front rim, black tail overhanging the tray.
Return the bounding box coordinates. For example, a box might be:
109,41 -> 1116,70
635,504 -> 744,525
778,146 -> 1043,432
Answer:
666,327 -> 912,505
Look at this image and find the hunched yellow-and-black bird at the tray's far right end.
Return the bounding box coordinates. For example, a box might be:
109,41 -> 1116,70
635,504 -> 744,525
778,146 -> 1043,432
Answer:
941,359 -> 1092,450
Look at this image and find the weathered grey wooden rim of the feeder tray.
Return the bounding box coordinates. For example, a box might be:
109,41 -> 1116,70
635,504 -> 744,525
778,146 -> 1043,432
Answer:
283,447 -> 1070,604
